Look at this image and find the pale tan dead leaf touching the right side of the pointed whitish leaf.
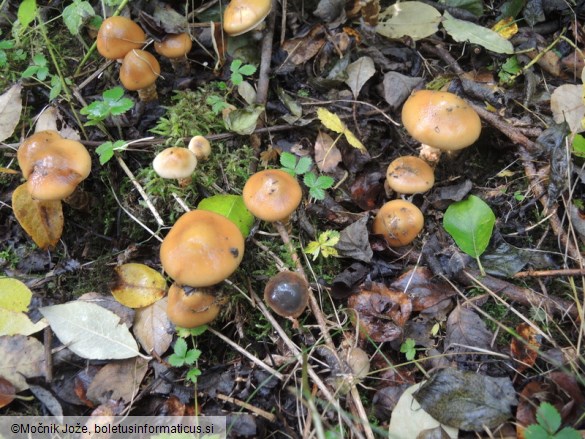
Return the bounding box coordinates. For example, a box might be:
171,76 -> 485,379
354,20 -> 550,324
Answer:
133,297 -> 173,356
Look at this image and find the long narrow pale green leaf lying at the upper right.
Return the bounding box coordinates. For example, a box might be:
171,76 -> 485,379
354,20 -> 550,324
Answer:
443,11 -> 514,55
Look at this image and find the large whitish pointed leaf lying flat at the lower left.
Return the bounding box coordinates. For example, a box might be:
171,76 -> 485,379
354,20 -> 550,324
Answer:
39,301 -> 140,360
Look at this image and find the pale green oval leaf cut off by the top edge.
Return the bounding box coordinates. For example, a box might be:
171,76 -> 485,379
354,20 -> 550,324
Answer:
376,1 -> 441,41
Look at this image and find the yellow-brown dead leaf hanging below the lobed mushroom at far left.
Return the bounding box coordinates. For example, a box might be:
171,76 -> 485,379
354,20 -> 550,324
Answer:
12,183 -> 63,250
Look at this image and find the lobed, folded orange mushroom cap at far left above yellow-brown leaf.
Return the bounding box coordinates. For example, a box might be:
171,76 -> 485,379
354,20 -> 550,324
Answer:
17,130 -> 91,201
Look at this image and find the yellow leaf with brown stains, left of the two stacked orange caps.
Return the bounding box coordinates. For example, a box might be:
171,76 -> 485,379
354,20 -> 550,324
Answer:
112,263 -> 167,308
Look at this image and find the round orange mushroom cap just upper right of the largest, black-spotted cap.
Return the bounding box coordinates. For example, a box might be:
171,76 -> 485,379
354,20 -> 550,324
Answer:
242,169 -> 303,222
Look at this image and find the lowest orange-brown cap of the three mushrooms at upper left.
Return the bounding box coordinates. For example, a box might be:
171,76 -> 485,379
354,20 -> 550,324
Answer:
120,49 -> 160,91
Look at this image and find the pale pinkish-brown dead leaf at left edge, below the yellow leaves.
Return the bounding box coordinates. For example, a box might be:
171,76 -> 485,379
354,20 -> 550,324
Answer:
0,335 -> 45,392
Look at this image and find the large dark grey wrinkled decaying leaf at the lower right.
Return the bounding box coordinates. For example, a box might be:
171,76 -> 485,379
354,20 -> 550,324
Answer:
413,368 -> 516,431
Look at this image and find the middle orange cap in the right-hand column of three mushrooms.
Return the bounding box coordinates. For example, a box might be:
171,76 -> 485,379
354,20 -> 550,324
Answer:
386,155 -> 435,194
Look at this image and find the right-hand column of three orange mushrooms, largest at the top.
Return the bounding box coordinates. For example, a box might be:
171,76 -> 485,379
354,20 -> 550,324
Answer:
372,90 -> 481,247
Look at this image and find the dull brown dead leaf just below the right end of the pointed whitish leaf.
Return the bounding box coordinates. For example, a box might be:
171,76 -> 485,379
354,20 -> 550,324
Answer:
87,358 -> 148,404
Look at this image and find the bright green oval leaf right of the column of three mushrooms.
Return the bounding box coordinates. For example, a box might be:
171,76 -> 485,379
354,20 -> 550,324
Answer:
443,195 -> 496,258
